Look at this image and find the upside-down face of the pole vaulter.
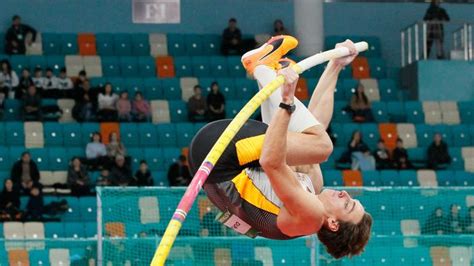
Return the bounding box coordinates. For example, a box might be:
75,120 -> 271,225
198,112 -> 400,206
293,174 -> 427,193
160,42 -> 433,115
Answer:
319,189 -> 365,230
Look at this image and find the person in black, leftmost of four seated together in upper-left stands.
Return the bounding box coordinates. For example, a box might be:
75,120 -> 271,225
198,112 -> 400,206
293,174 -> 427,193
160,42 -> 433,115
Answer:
72,80 -> 97,122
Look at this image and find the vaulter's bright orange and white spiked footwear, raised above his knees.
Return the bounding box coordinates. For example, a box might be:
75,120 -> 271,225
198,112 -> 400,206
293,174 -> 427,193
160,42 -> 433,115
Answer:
241,35 -> 298,75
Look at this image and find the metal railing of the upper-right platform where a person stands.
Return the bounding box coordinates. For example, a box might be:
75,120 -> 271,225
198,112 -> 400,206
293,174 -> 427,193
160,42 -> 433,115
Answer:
400,21 -> 474,67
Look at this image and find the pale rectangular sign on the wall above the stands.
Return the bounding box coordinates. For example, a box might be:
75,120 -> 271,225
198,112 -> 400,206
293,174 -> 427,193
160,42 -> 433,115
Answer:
132,0 -> 181,24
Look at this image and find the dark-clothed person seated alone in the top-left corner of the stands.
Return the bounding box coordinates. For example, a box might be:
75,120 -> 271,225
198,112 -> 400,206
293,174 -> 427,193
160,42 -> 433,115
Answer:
5,15 -> 36,54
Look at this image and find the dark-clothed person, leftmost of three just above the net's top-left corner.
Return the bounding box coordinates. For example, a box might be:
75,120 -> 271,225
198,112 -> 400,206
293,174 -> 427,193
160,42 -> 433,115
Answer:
67,157 -> 91,196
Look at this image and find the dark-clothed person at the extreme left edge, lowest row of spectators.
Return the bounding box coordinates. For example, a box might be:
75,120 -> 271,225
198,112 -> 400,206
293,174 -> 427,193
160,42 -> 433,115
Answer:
0,179 -> 21,221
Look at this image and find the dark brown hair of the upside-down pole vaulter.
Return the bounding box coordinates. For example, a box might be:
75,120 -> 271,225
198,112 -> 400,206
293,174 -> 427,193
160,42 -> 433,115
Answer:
318,212 -> 372,259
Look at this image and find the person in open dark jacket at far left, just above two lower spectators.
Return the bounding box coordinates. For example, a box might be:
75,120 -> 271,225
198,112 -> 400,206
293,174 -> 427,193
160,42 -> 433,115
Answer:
10,151 -> 40,194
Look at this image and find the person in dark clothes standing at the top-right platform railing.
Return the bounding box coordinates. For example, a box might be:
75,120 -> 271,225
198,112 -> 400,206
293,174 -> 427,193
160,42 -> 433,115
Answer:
423,0 -> 449,59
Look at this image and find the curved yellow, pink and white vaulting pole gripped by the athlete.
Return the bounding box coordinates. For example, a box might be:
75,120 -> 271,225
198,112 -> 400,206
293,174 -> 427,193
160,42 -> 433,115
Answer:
151,42 -> 368,266
